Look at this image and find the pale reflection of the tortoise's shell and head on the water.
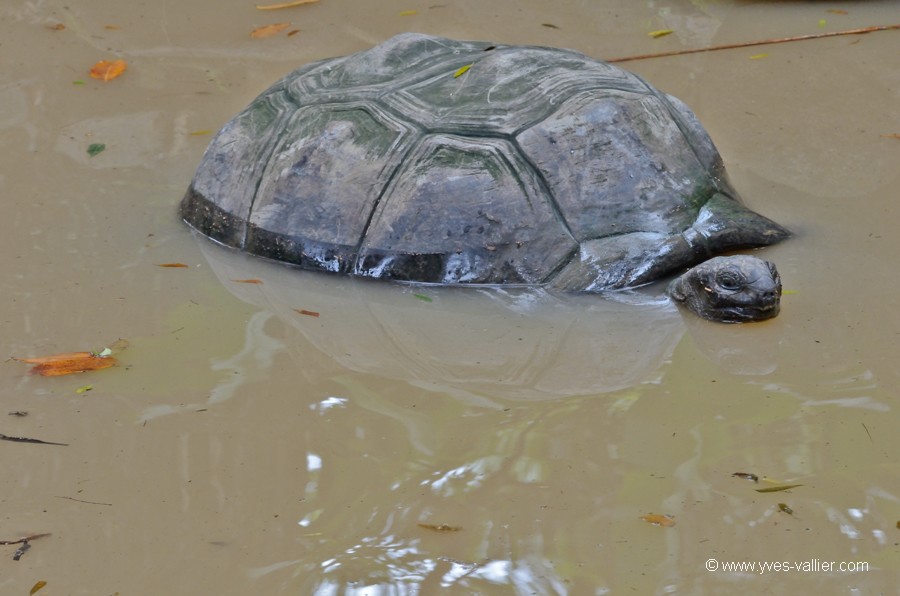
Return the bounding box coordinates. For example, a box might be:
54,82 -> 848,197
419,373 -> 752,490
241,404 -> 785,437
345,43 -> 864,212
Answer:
192,238 -> 788,404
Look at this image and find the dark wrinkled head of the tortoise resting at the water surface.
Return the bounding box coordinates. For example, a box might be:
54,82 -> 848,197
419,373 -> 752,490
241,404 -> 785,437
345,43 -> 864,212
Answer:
667,255 -> 781,323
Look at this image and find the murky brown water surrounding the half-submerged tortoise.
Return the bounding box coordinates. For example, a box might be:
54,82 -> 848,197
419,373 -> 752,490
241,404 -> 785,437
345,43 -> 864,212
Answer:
0,0 -> 900,594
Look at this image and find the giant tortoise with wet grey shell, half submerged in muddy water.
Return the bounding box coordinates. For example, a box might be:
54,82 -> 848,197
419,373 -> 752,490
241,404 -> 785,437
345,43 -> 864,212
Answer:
181,33 -> 788,322
